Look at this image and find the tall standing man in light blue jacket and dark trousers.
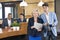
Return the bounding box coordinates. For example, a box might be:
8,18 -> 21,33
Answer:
40,3 -> 58,40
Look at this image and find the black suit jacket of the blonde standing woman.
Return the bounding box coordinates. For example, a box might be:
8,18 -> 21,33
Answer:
28,17 -> 43,36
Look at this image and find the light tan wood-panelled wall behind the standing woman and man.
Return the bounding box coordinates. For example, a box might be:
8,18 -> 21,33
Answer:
25,0 -> 54,15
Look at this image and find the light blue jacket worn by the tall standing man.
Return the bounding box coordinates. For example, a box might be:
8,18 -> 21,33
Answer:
40,12 -> 58,36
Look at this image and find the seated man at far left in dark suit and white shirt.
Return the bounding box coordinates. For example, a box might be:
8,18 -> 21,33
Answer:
2,13 -> 13,28
